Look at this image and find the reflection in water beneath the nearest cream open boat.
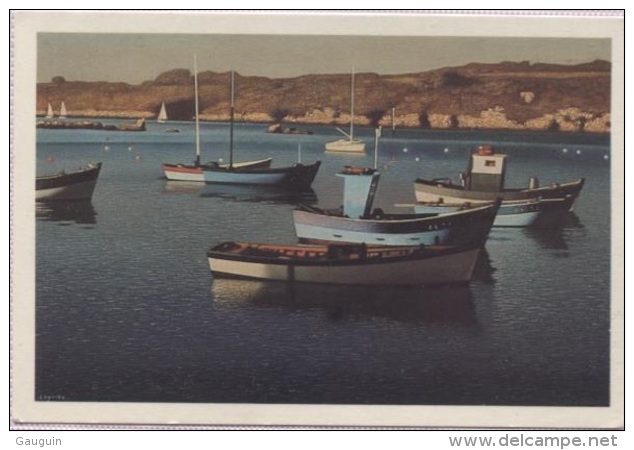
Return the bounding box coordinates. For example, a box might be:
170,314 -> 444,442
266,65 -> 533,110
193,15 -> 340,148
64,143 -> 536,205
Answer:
211,278 -> 477,327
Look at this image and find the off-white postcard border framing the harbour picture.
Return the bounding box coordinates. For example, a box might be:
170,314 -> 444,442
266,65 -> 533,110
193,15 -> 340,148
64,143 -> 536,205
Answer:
11,11 -> 624,429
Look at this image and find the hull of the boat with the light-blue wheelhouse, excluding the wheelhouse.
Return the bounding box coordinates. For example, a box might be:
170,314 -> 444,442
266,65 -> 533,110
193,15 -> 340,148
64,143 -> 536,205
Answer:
293,204 -> 498,246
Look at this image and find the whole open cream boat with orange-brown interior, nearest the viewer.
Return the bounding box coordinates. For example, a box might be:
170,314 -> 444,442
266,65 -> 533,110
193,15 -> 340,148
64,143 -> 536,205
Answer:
207,242 -> 480,286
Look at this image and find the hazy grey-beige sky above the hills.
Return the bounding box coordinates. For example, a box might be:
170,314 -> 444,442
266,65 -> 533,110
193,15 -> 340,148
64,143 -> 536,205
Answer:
37,33 -> 611,84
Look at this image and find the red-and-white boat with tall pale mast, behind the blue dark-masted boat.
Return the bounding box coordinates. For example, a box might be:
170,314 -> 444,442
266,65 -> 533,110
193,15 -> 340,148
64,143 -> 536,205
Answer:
161,56 -> 272,183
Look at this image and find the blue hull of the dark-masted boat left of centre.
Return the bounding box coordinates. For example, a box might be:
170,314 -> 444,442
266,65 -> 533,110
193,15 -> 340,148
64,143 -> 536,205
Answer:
203,161 -> 321,189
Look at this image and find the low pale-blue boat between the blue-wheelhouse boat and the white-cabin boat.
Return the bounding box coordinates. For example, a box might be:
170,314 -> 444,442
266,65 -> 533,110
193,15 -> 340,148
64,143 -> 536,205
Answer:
396,195 -> 574,227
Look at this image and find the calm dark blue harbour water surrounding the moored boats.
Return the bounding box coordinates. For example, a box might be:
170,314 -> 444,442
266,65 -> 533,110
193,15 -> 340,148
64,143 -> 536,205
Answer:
36,119 -> 610,405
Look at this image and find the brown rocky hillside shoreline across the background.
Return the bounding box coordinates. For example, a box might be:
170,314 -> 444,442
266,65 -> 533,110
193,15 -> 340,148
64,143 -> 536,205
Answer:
37,61 -> 611,133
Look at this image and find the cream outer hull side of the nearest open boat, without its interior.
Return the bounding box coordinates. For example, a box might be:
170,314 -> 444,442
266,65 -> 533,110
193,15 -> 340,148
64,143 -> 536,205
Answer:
207,243 -> 480,286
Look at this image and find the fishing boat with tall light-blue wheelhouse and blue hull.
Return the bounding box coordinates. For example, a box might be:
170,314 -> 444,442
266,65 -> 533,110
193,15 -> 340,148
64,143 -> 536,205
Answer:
293,166 -> 500,246
